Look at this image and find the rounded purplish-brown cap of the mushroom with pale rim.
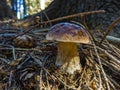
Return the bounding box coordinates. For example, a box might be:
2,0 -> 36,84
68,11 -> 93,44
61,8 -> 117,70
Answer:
46,22 -> 90,44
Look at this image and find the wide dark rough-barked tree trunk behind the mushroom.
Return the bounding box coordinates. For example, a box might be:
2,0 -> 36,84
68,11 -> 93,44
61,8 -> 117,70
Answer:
41,0 -> 120,37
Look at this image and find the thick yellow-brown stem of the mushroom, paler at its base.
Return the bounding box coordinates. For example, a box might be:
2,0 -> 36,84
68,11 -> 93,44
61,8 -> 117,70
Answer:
56,42 -> 81,74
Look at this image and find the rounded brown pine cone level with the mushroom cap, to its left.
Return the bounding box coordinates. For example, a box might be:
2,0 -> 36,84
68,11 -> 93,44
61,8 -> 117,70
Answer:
14,35 -> 36,48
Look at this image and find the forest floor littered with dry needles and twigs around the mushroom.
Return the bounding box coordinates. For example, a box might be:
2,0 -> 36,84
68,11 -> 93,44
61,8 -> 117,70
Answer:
0,12 -> 120,90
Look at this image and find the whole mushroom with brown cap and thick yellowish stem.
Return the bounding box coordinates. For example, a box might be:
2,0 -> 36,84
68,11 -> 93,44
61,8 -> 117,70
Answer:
46,22 -> 90,74
